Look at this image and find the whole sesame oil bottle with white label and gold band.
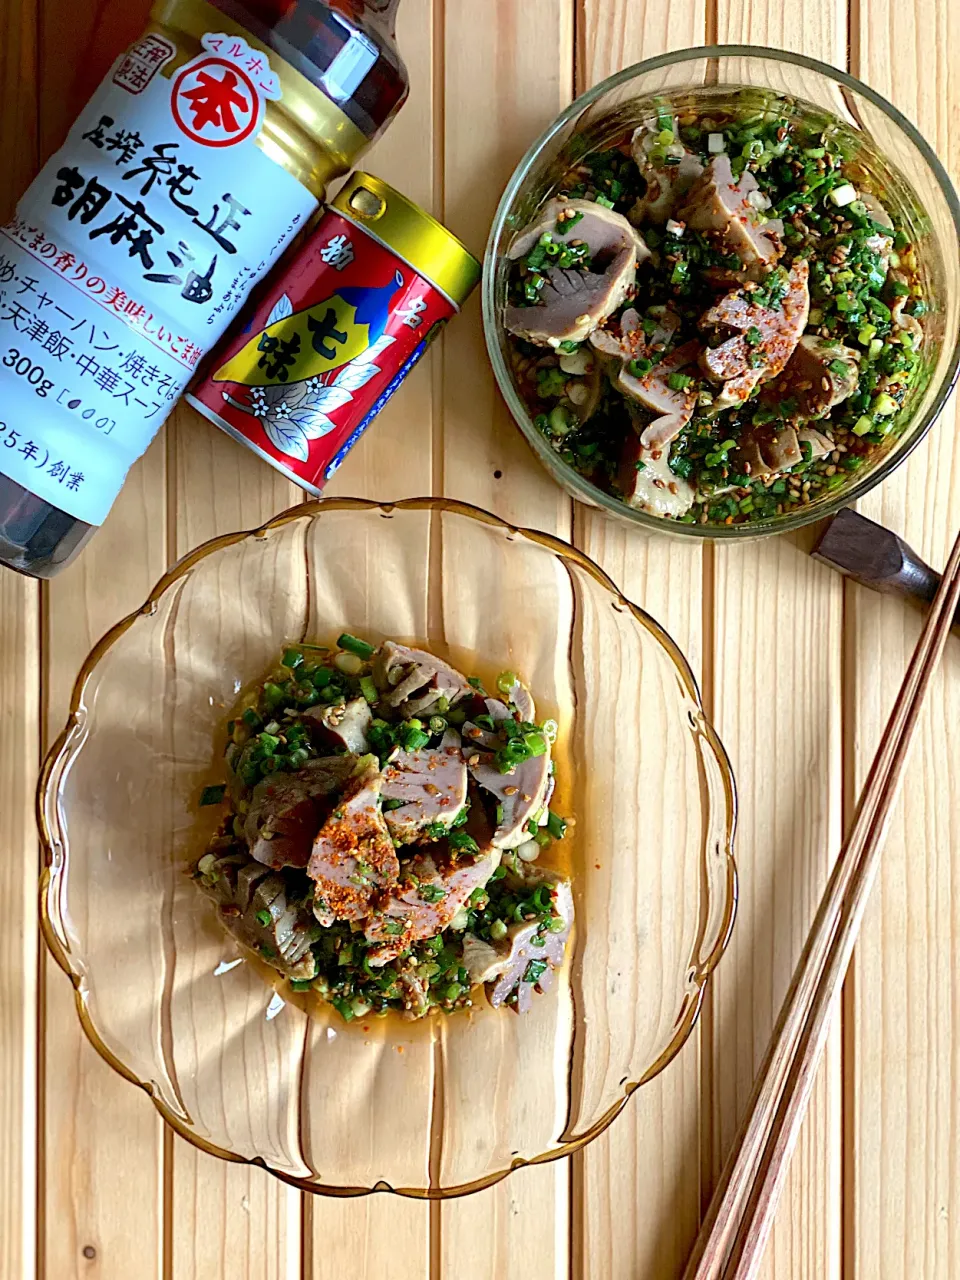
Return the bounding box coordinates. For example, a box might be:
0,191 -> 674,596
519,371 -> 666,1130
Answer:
0,0 -> 408,577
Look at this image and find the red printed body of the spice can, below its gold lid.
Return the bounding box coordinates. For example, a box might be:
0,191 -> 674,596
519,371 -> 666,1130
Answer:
188,210 -> 456,493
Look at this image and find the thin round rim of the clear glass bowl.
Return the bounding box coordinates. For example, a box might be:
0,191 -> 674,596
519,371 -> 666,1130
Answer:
483,45 -> 960,541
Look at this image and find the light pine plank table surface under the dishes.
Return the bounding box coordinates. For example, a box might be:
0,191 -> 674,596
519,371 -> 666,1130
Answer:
0,0 -> 960,1280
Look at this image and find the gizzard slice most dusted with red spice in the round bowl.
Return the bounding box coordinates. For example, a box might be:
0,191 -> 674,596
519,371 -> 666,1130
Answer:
700,259 -> 810,412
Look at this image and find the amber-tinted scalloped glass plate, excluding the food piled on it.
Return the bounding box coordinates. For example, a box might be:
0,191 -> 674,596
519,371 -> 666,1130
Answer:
38,498 -> 736,1198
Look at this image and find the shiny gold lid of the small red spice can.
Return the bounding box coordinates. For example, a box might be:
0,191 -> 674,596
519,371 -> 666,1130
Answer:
333,173 -> 483,307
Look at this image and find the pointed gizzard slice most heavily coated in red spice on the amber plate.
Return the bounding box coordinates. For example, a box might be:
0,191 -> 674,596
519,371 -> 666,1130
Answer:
307,756 -> 399,924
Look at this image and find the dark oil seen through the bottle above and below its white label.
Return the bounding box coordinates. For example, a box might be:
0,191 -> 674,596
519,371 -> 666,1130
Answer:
0,0 -> 410,577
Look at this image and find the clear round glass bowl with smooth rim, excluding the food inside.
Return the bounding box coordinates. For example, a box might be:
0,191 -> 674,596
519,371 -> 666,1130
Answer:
483,45 -> 960,540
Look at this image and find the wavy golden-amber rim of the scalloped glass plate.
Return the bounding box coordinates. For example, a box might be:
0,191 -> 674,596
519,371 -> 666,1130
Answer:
36,497 -> 737,1201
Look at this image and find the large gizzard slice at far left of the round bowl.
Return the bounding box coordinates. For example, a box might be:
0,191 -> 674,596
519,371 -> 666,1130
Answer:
504,200 -> 650,347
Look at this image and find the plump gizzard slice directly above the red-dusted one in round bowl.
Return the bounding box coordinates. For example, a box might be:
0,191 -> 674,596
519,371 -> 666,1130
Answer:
676,155 -> 783,280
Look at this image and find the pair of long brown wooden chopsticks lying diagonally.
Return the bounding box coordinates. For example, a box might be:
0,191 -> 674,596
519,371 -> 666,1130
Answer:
684,522 -> 960,1280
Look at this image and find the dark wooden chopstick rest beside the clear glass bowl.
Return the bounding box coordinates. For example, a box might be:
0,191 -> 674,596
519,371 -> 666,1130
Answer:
810,508 -> 960,628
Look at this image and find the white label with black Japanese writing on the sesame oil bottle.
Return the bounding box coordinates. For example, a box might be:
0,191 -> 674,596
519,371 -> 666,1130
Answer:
0,33 -> 317,525
